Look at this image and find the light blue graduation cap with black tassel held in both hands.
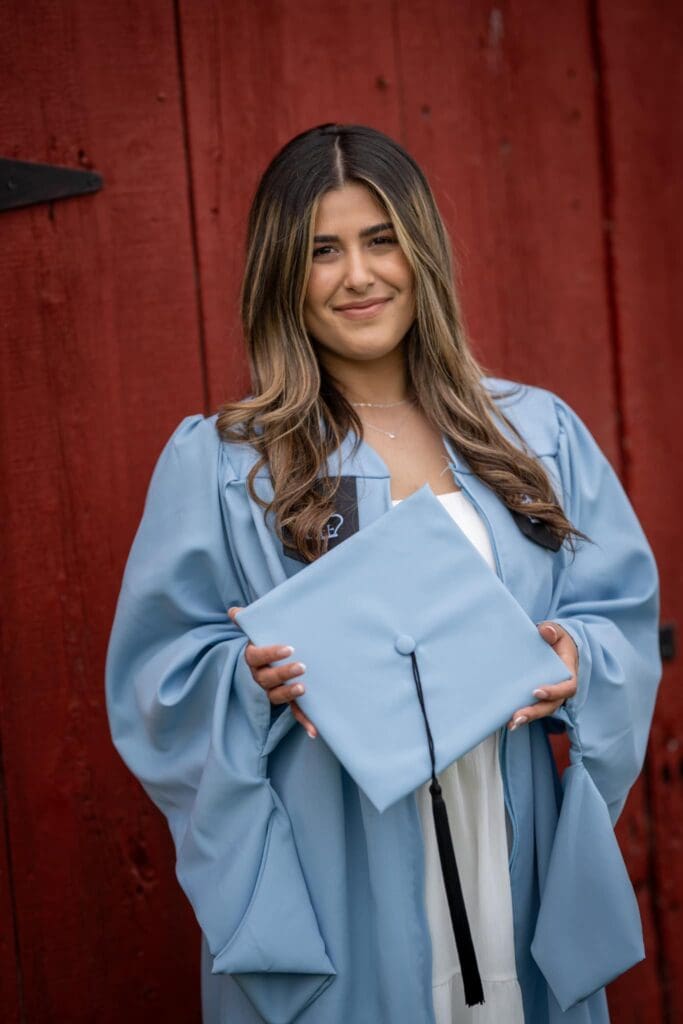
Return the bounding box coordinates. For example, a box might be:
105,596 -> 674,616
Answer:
236,484 -> 570,1006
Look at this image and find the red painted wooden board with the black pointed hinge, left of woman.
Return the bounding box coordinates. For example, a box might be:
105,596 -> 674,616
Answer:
0,0 -> 203,1024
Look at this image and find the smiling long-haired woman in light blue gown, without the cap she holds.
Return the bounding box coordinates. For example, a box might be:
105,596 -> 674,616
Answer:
106,125 -> 659,1024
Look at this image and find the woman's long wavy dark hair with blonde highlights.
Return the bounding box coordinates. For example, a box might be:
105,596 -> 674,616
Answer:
217,124 -> 583,561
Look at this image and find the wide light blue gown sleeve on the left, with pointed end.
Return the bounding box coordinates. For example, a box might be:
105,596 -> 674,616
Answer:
105,416 -> 335,1022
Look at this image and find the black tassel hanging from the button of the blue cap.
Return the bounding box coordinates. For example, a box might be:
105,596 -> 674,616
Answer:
411,651 -> 484,1007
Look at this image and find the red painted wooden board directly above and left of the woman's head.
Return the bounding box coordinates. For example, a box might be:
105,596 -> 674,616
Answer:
174,0 -> 400,408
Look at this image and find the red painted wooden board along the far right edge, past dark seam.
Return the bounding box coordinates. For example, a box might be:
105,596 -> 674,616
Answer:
598,0 -> 683,1021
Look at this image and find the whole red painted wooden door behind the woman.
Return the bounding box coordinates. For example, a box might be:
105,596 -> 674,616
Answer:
0,0 -> 683,1024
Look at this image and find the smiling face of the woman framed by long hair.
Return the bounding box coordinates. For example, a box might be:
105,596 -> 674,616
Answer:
304,182 -> 415,361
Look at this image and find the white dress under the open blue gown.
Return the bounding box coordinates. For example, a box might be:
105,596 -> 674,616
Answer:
392,490 -> 524,1024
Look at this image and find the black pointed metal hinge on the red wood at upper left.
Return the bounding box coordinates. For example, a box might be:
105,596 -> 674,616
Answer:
0,158 -> 102,213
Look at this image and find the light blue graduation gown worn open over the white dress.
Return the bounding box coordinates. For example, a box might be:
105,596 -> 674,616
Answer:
106,380 -> 660,1024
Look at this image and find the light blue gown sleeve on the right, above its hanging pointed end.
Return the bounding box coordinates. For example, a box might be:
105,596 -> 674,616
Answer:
548,398 -> 661,822
